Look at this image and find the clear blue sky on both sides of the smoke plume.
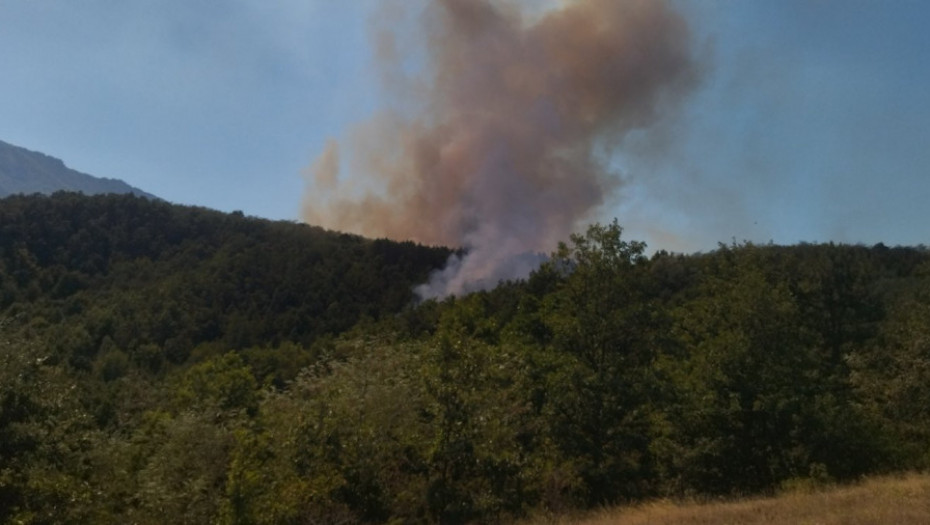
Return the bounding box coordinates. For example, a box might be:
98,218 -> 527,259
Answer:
0,0 -> 930,252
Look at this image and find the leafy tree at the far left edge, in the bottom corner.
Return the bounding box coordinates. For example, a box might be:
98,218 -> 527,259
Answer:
0,323 -> 98,523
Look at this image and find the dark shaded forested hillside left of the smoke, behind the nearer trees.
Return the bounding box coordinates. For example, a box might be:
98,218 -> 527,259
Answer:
0,193 -> 449,372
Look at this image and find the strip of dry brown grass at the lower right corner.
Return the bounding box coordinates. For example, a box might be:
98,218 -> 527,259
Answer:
520,474 -> 930,525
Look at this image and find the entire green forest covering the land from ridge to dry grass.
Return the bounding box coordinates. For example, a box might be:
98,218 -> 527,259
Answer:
0,194 -> 930,523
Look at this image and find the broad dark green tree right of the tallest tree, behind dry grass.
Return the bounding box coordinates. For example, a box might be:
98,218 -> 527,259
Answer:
656,245 -> 876,494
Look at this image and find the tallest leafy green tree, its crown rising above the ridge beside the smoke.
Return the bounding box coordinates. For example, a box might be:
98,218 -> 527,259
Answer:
531,221 -> 661,506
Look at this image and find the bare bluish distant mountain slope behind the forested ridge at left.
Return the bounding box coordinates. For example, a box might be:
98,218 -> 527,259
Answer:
0,141 -> 155,198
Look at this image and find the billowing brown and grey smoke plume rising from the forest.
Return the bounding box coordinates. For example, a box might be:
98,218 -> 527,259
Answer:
303,0 -> 695,298
